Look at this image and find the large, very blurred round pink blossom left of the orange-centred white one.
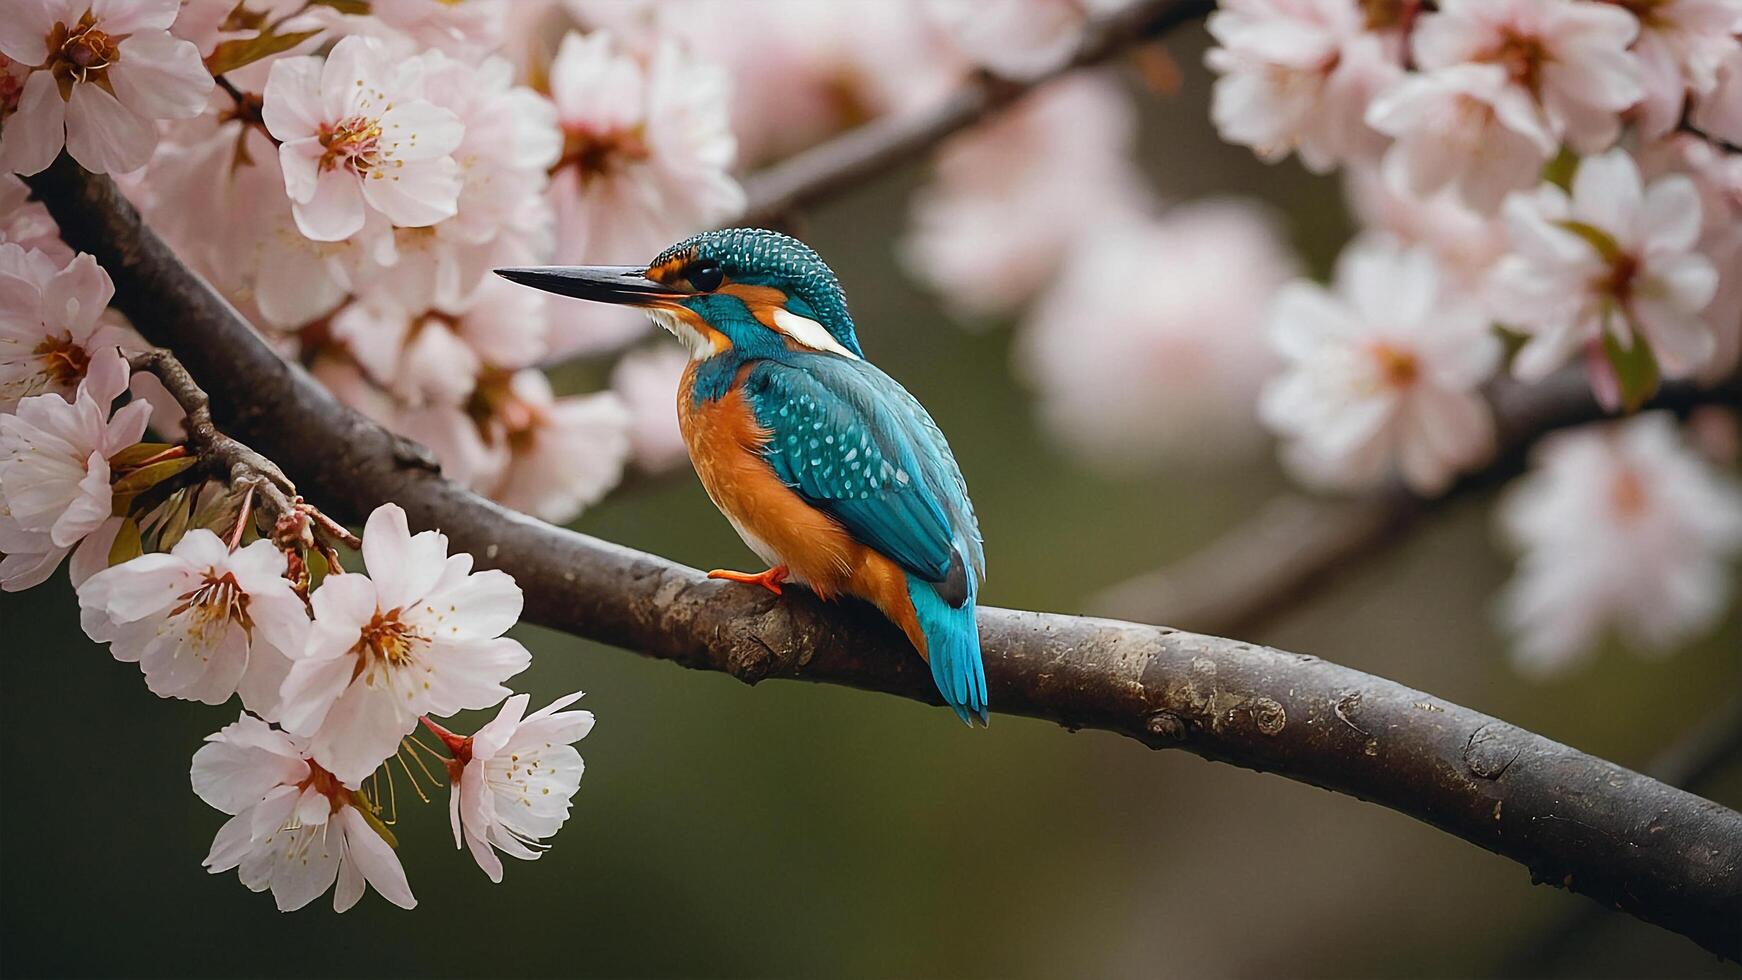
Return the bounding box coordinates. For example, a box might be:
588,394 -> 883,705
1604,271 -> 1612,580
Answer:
1016,200 -> 1296,470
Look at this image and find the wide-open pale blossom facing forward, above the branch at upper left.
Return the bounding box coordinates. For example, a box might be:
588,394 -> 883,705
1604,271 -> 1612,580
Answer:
261,37 -> 463,242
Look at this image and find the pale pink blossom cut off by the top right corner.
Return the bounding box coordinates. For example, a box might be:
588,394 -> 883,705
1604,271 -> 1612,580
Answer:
1634,0 -> 1742,139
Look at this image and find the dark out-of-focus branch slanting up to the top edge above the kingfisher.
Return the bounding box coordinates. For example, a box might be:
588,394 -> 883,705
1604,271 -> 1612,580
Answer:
740,0 -> 1214,225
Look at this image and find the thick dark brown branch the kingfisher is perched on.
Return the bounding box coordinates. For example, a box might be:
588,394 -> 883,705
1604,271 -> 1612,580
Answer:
30,157 -> 1742,957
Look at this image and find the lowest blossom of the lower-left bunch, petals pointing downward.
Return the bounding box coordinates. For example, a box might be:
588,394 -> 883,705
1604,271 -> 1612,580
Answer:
192,714 -> 418,912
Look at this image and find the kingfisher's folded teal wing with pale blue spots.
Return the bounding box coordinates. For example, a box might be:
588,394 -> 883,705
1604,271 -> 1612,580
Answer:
744,357 -> 981,604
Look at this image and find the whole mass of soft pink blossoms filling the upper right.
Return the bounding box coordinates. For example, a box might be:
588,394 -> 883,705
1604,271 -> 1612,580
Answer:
904,0 -> 1742,668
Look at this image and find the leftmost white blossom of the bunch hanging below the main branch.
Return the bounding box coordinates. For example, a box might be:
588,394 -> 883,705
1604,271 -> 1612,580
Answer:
78,527 -> 308,717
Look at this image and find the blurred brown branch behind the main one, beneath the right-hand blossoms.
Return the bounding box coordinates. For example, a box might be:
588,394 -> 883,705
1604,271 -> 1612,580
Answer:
1090,371 -> 1742,634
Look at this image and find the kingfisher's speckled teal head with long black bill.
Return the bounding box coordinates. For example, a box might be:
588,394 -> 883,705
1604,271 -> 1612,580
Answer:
496,228 -> 864,357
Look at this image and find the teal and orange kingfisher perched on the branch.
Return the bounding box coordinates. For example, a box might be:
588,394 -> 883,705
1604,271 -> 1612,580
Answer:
496,228 -> 986,726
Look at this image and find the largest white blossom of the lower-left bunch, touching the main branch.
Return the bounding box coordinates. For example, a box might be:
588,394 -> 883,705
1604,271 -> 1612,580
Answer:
279,503 -> 531,783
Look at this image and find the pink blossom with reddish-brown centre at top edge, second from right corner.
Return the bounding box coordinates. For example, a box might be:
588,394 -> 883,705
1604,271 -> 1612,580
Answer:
1411,0 -> 1644,153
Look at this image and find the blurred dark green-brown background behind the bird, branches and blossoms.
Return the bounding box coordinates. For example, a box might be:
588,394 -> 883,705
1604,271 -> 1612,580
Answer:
0,24 -> 1742,977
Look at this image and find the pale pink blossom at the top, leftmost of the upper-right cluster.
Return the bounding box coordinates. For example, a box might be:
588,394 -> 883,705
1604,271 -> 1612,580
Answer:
1204,0 -> 1402,174
